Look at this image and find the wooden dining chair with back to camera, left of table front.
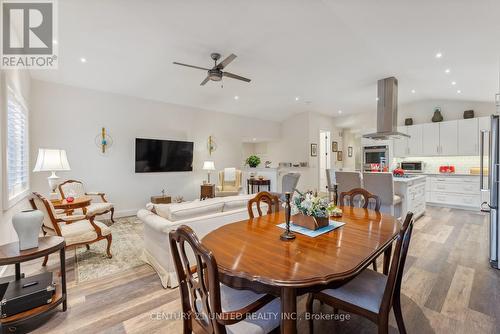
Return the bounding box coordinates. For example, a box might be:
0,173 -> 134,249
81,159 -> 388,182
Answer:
169,225 -> 280,334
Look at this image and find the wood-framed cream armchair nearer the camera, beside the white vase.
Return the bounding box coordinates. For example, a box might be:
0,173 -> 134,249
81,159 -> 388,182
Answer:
30,192 -> 112,266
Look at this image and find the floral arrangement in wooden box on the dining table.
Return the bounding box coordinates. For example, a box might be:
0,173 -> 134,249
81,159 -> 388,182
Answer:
291,191 -> 335,230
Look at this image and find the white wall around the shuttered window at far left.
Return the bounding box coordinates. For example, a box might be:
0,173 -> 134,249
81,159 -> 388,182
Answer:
0,70 -> 31,244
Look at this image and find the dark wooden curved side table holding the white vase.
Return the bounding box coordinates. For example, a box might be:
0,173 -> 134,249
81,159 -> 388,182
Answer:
0,236 -> 67,331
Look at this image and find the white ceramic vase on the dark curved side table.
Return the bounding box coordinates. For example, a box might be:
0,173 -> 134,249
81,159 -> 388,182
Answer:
12,210 -> 43,250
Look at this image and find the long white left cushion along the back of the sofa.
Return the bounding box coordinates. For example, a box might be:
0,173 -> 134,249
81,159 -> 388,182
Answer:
164,198 -> 224,222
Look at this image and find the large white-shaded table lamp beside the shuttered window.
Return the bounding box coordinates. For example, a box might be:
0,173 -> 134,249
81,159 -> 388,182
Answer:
33,148 -> 71,199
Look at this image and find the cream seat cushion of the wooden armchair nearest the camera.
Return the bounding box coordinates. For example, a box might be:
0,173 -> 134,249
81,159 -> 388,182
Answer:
46,219 -> 111,246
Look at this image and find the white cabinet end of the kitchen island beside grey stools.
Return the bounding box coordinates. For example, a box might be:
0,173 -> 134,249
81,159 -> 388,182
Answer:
394,175 -> 426,219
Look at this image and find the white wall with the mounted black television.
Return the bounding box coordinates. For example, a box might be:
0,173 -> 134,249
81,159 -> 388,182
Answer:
31,81 -> 280,214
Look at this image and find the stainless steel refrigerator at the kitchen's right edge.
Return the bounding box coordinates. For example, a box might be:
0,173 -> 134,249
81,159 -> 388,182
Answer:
480,94 -> 500,269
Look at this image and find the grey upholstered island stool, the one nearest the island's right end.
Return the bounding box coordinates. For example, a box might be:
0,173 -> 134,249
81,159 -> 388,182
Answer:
363,172 -> 402,218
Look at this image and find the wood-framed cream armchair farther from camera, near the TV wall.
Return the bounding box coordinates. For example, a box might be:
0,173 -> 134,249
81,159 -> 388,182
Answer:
58,180 -> 115,223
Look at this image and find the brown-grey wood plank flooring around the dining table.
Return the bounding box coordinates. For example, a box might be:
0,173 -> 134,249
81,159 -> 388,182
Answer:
2,207 -> 500,334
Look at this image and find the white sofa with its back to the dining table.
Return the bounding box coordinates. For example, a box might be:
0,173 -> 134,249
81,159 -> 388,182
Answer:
137,195 -> 258,288
